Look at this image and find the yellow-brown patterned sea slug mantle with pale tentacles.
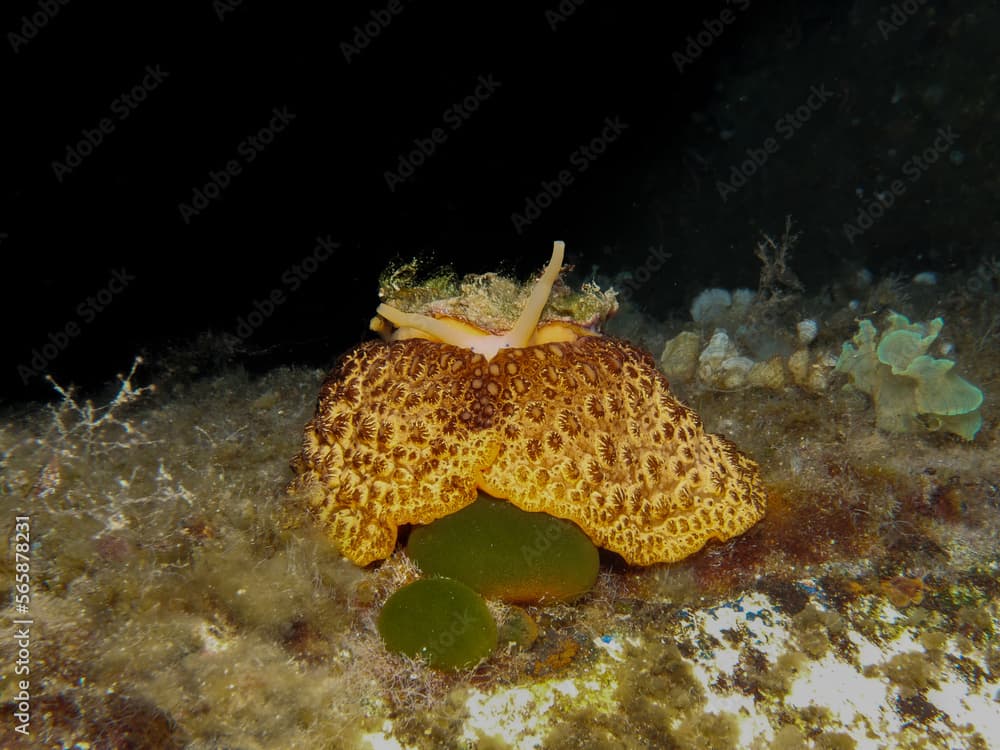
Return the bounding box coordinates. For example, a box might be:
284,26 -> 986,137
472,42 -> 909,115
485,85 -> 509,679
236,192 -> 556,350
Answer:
289,242 -> 766,565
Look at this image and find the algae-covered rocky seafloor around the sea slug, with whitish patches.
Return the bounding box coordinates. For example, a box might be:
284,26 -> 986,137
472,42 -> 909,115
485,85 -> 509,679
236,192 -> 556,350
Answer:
0,254 -> 1000,750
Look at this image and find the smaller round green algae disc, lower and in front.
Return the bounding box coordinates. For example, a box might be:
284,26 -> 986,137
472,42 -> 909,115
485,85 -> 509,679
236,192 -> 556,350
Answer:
378,578 -> 497,669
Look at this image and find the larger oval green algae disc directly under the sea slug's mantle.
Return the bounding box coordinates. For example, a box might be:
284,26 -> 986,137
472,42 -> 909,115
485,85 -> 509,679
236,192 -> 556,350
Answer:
407,494 -> 599,602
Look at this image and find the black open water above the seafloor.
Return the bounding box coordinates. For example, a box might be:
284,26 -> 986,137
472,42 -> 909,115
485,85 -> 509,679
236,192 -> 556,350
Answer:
0,0 -> 1000,400
